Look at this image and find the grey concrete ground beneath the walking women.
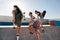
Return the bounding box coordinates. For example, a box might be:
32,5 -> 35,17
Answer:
0,27 -> 60,40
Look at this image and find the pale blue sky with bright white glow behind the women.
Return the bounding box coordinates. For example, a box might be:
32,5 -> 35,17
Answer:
0,0 -> 60,19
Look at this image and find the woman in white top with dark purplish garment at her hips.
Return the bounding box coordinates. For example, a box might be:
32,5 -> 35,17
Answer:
33,11 -> 41,40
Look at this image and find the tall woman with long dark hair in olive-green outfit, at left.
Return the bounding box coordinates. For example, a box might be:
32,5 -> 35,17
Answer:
12,5 -> 23,39
